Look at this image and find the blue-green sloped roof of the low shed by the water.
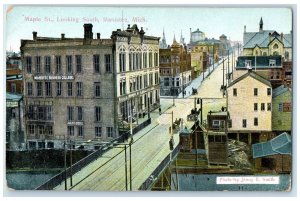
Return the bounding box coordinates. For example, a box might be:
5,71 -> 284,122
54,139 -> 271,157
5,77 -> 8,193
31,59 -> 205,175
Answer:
252,132 -> 292,158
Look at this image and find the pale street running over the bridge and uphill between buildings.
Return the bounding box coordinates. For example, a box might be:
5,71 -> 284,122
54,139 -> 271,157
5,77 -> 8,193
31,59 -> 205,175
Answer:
55,52 -> 237,191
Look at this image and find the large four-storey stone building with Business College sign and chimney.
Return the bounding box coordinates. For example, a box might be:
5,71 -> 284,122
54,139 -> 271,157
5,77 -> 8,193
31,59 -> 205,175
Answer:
21,24 -> 159,149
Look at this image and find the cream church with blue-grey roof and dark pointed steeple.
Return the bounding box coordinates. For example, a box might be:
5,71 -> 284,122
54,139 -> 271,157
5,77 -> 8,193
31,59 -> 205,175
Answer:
243,18 -> 293,61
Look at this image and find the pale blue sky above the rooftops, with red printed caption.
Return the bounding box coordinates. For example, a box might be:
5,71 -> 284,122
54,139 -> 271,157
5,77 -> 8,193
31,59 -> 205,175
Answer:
4,5 -> 292,51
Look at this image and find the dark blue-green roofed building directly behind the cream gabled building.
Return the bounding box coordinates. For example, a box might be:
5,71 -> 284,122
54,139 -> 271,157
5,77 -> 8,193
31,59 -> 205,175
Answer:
233,55 -> 284,88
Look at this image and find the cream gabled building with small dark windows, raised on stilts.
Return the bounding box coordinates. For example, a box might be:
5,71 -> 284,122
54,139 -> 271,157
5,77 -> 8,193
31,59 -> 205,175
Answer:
227,70 -> 272,144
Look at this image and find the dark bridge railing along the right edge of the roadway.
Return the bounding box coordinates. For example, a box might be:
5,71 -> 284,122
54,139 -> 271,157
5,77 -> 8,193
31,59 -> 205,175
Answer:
139,145 -> 179,191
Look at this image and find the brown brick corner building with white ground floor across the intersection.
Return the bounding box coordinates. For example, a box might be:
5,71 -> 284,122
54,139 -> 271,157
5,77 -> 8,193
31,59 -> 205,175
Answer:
159,37 -> 192,96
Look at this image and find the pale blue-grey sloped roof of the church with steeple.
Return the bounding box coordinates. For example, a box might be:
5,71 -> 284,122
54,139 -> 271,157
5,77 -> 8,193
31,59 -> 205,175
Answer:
244,30 -> 292,48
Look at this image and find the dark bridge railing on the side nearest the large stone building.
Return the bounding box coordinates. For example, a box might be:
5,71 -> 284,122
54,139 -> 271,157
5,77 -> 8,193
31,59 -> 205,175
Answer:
36,118 -> 151,190
